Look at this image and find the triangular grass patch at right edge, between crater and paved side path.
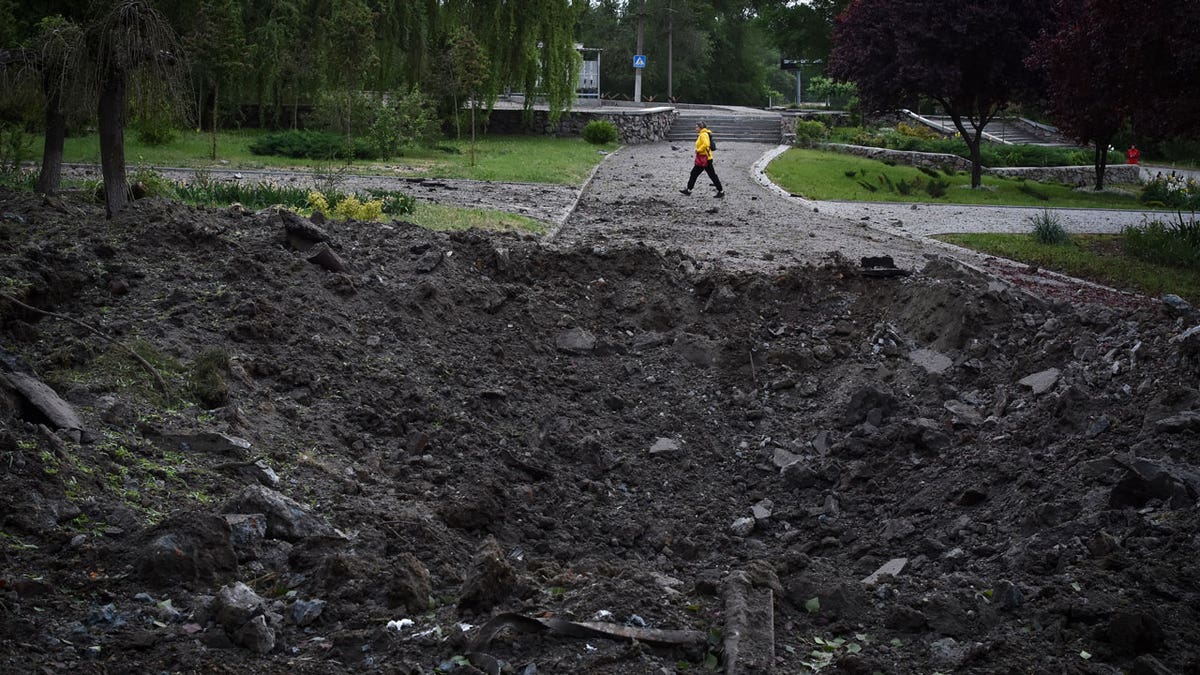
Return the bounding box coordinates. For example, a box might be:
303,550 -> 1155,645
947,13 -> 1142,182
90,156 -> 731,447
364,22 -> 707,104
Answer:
935,234 -> 1200,305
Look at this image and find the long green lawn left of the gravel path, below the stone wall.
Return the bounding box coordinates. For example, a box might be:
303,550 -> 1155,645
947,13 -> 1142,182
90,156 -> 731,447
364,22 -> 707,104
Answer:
57,131 -> 616,185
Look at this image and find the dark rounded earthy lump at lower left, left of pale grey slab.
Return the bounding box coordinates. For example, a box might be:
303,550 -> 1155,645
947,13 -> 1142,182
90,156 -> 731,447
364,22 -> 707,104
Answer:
134,513 -> 238,587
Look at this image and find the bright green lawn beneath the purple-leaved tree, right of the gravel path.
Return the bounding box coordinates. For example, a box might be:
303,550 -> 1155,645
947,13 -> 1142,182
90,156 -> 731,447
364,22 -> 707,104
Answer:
767,148 -> 1145,209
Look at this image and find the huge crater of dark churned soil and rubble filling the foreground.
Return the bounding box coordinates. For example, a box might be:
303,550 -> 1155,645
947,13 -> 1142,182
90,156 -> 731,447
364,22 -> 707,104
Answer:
0,192 -> 1200,674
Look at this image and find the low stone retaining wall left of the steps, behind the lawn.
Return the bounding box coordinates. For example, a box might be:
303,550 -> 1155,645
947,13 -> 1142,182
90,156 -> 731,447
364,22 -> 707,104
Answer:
487,107 -> 679,145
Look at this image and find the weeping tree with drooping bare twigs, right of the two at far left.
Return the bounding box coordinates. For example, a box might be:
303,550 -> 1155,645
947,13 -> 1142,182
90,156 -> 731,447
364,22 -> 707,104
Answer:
86,0 -> 186,217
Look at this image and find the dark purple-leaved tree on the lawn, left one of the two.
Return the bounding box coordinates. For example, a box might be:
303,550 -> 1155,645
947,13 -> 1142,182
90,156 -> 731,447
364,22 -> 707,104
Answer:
830,0 -> 1044,187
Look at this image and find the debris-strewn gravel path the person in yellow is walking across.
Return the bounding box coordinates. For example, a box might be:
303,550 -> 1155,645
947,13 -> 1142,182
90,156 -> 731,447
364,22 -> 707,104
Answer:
551,142 -> 938,269
